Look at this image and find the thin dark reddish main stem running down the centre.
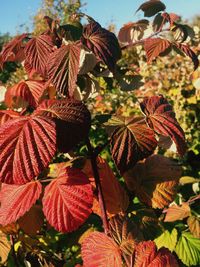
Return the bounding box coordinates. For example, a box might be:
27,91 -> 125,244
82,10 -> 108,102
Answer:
86,138 -> 109,234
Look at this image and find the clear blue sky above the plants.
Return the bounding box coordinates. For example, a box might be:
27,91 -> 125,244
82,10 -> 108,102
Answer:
0,0 -> 200,35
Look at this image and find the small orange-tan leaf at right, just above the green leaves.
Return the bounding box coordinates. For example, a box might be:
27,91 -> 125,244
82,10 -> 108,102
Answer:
164,202 -> 191,222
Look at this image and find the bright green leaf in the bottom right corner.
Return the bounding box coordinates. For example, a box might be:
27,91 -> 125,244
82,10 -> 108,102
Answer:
175,232 -> 200,266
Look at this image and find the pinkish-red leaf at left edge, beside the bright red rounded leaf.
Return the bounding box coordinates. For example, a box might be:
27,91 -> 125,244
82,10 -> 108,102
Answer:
0,181 -> 42,225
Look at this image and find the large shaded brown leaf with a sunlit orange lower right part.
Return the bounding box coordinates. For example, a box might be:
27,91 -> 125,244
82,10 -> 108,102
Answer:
124,155 -> 182,209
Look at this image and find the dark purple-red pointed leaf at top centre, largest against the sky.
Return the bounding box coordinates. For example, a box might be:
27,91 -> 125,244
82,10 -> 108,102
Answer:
81,21 -> 121,71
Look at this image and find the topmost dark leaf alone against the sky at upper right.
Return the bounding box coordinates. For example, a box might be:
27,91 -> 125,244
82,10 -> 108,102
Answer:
136,0 -> 166,17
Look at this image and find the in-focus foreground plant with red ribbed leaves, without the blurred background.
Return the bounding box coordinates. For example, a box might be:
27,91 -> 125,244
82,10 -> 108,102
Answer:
0,0 -> 200,267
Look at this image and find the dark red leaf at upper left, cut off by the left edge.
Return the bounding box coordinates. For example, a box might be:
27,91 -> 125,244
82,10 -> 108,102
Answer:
0,33 -> 28,65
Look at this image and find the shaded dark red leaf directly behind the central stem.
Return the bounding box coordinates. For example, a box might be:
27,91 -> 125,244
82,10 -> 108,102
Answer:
82,156 -> 129,216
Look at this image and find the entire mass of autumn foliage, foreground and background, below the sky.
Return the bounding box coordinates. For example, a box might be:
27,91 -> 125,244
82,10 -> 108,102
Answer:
0,0 -> 200,267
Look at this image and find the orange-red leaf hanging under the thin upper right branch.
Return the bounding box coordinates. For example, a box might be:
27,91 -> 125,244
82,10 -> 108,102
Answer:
144,38 -> 171,63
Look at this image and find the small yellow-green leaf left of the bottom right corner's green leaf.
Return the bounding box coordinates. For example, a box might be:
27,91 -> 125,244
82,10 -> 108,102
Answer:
154,228 -> 178,252
